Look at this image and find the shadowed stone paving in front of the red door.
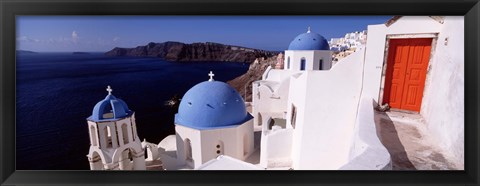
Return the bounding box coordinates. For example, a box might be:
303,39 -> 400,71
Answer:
375,110 -> 464,170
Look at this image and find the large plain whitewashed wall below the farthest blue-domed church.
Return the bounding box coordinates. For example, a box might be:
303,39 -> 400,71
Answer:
287,47 -> 364,170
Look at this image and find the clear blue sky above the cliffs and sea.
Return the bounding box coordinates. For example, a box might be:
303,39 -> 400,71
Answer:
16,16 -> 392,52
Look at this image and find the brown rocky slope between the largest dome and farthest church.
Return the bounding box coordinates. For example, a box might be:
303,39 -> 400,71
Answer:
227,56 -> 278,102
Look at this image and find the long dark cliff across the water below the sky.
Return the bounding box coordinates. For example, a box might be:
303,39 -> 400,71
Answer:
105,41 -> 278,63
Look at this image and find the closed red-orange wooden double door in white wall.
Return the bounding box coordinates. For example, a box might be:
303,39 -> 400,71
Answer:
383,38 -> 432,112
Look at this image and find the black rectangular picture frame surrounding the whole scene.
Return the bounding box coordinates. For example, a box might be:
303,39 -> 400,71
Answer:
0,0 -> 480,185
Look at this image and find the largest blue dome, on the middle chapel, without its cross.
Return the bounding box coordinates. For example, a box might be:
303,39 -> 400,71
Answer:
175,81 -> 252,130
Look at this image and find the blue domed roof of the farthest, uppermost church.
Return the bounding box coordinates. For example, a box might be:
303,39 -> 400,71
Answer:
288,28 -> 330,50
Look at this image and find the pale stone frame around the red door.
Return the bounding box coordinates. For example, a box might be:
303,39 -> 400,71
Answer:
378,33 -> 438,112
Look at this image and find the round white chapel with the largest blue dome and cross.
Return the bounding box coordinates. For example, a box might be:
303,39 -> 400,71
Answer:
175,72 -> 253,168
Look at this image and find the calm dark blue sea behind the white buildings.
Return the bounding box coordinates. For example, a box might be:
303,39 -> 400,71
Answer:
16,53 -> 248,170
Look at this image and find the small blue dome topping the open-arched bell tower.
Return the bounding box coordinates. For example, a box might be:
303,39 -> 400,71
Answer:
87,94 -> 133,122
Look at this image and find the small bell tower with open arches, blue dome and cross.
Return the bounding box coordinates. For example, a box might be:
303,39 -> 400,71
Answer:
87,86 -> 146,170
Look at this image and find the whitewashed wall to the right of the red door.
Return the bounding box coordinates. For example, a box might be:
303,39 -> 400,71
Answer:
421,17 -> 468,164
